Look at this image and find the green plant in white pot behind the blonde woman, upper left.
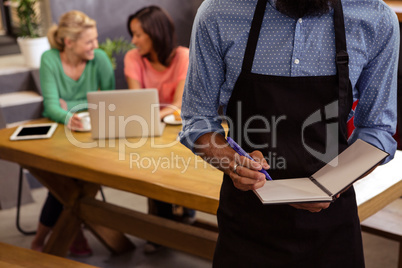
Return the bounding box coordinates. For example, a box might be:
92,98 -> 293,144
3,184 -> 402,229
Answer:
11,0 -> 50,68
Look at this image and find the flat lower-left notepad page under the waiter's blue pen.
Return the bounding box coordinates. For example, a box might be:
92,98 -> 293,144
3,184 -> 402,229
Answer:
254,178 -> 332,204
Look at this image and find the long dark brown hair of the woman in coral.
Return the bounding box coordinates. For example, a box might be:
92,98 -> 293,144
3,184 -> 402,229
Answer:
127,6 -> 177,66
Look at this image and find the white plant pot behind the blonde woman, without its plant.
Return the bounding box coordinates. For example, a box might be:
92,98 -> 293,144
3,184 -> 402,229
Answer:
17,37 -> 50,68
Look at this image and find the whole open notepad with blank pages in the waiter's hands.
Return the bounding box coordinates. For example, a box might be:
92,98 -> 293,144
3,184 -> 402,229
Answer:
254,140 -> 388,204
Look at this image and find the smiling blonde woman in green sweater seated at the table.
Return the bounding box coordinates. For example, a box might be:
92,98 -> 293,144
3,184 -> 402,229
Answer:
31,10 -> 115,256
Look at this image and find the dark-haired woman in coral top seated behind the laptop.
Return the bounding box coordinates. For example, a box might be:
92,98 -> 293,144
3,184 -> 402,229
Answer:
124,6 -> 195,253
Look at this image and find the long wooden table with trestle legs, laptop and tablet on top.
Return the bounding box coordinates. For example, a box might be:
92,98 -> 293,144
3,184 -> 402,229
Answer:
0,120 -> 402,259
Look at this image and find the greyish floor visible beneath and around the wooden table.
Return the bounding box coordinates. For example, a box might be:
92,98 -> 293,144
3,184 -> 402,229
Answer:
0,188 -> 402,268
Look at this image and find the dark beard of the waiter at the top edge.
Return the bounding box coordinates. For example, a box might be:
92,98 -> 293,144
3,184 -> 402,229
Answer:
276,0 -> 338,19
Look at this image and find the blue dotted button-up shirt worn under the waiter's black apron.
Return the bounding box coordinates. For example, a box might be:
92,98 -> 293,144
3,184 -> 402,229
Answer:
180,0 -> 399,161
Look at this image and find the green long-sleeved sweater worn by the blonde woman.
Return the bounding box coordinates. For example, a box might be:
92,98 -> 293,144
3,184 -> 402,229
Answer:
39,49 -> 115,124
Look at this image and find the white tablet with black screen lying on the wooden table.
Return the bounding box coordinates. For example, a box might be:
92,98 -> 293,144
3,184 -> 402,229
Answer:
10,123 -> 57,141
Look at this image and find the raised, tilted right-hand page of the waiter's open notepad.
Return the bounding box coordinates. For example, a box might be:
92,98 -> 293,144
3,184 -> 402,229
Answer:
312,140 -> 388,194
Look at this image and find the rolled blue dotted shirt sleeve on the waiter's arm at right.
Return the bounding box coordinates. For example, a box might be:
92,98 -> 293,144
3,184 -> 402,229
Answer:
349,4 -> 400,163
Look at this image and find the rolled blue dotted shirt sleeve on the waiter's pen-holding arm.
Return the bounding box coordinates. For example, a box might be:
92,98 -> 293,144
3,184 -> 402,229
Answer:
180,0 -> 225,152
